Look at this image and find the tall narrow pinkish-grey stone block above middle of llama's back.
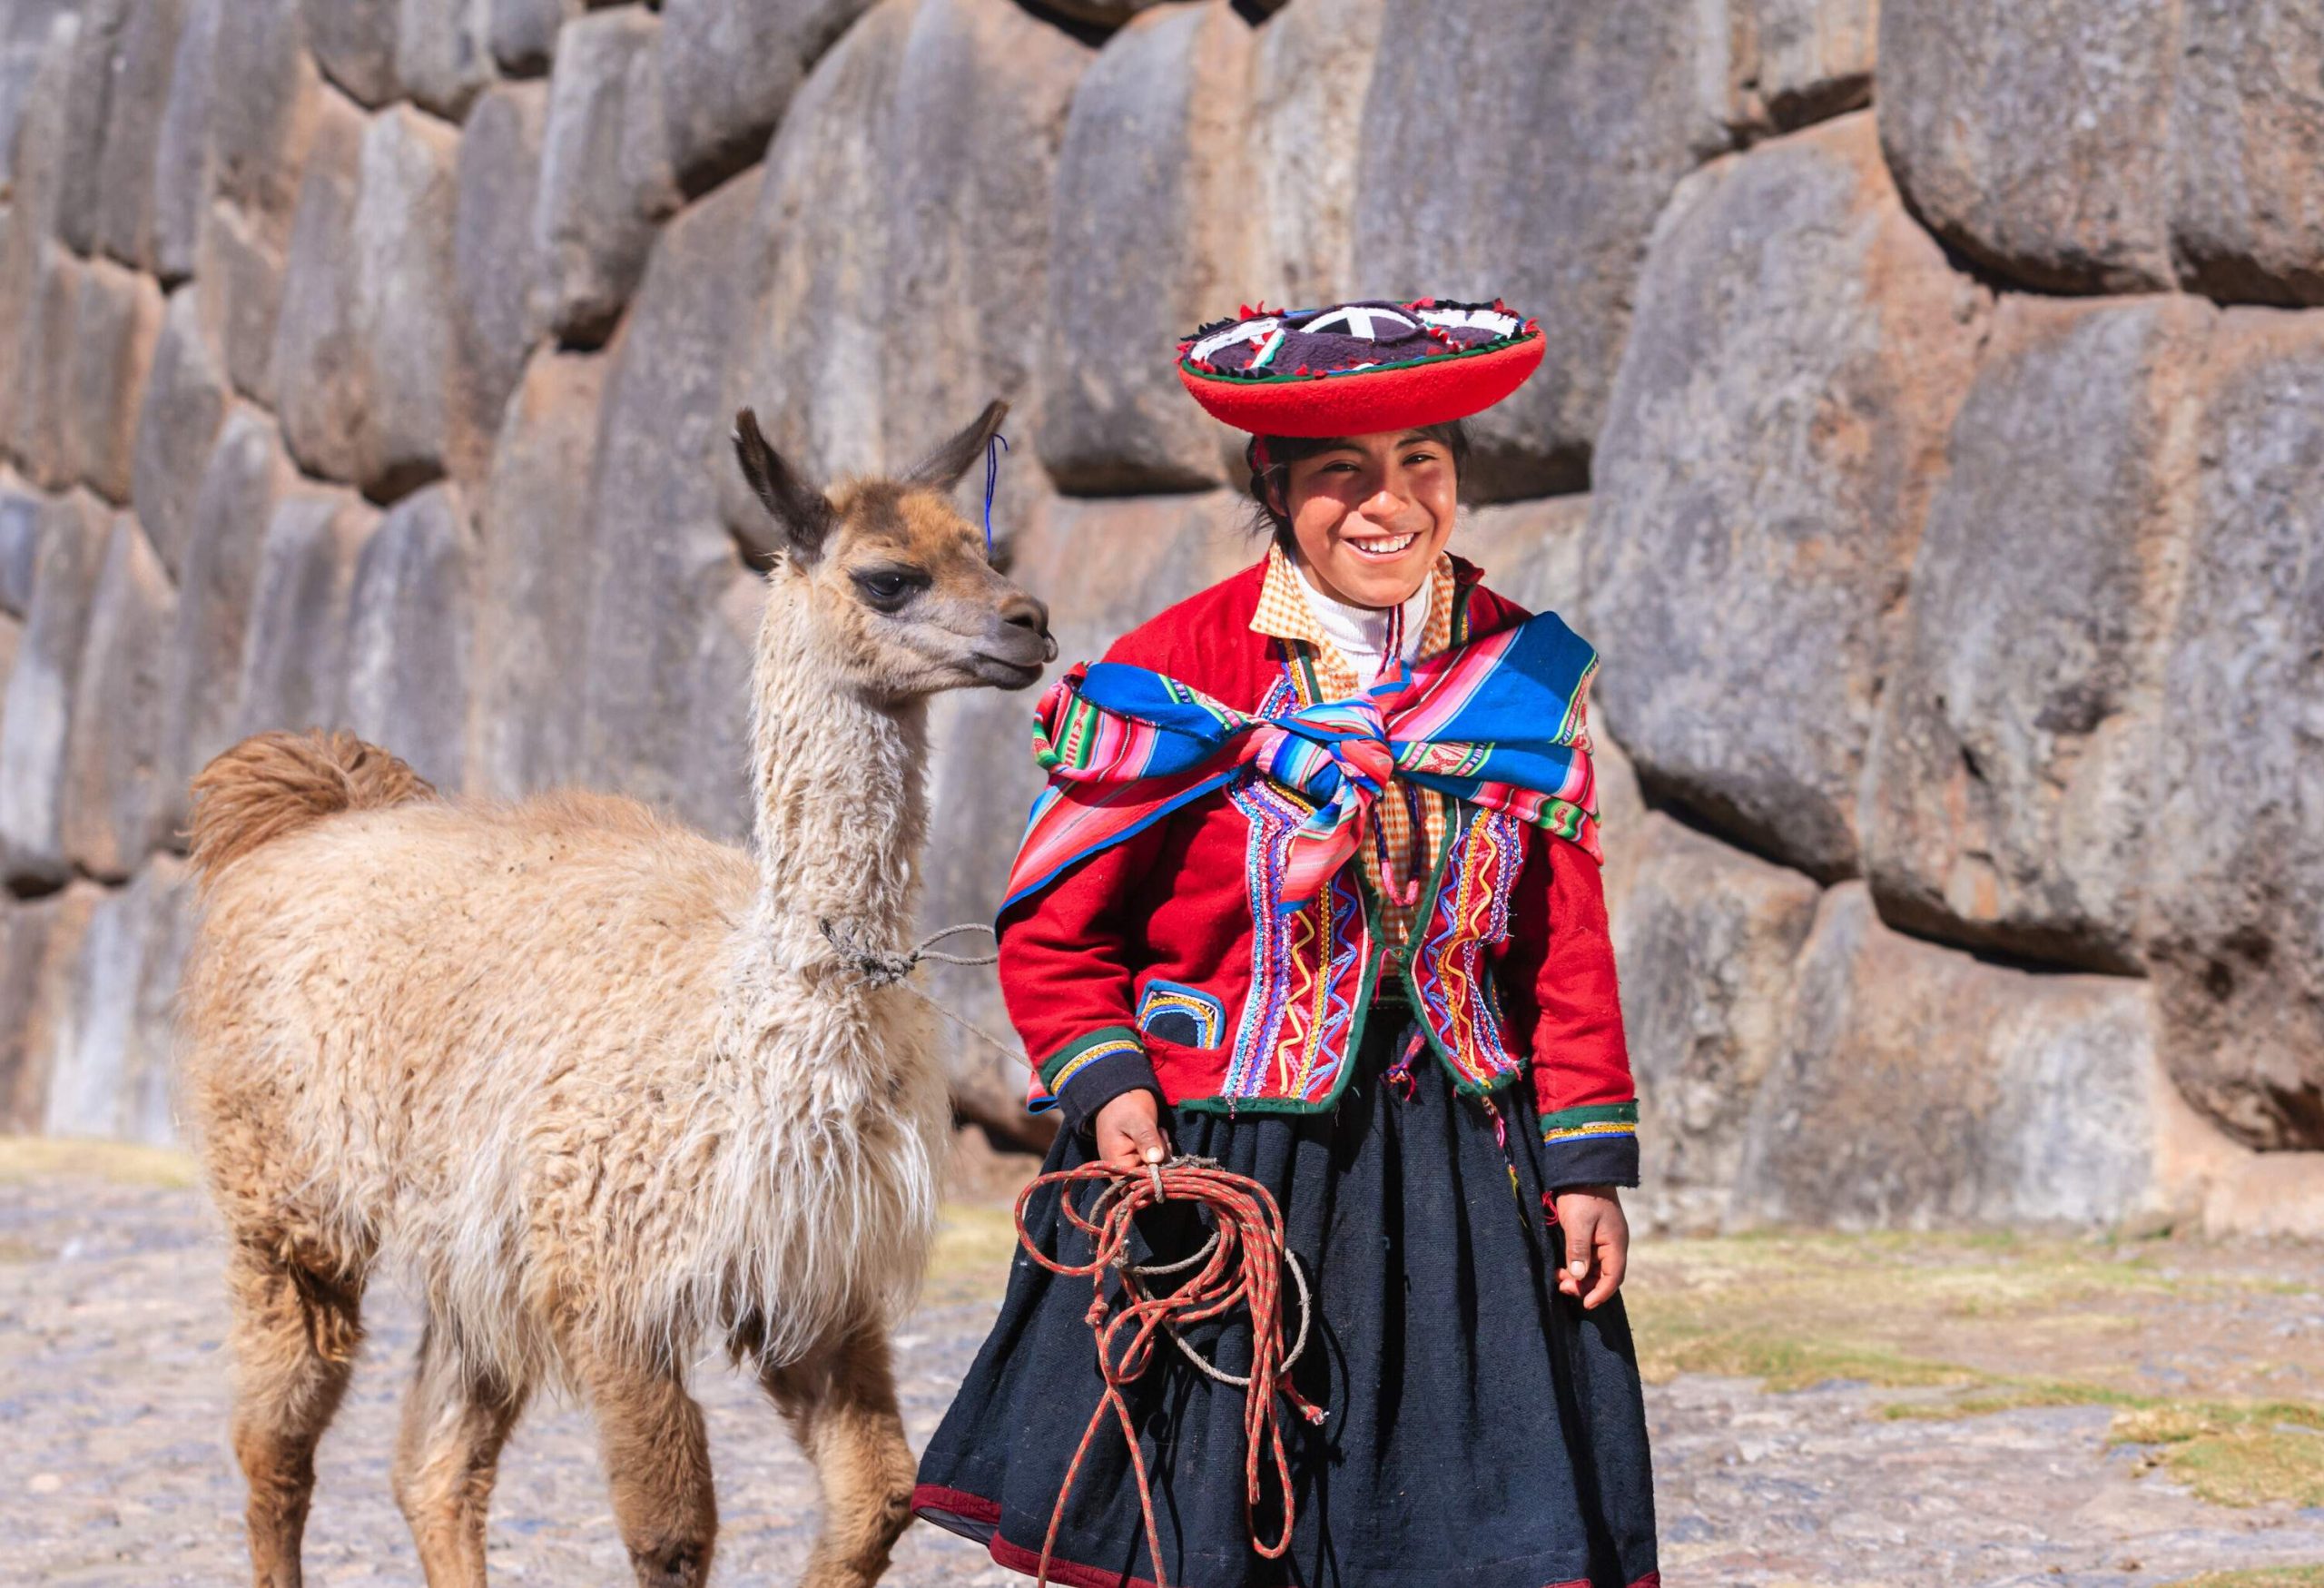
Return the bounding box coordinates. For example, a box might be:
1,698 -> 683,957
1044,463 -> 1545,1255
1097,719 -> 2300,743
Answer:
468,349 -> 599,797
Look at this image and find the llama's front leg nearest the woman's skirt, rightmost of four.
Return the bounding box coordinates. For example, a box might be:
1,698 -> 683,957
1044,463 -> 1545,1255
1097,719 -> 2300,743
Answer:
763,1326 -> 916,1588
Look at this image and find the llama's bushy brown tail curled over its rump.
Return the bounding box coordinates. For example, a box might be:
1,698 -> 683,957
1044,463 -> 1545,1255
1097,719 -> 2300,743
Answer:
186,730 -> 435,886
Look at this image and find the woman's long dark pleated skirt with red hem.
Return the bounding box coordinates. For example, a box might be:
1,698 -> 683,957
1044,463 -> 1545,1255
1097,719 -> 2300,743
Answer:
913,1004 -> 1657,1588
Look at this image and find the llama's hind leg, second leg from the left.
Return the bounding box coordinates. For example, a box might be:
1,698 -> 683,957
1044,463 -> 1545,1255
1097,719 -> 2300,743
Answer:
395,1323 -> 526,1588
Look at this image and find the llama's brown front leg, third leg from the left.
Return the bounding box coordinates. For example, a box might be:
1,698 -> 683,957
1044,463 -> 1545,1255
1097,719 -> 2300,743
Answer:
578,1360 -> 718,1588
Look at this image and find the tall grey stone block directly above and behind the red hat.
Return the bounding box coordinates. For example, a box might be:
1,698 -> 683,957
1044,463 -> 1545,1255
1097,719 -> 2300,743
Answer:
1357,0 -> 1729,498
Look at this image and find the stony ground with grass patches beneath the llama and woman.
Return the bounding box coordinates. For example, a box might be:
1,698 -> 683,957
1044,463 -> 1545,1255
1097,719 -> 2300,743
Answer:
0,1153 -> 2324,1588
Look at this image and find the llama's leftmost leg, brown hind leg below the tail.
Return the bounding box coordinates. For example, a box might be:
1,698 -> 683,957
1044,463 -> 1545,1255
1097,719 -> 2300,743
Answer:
228,1241 -> 362,1588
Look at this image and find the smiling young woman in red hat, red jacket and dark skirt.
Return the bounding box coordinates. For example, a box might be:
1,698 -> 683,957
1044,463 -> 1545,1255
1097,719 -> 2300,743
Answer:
913,300 -> 1657,1588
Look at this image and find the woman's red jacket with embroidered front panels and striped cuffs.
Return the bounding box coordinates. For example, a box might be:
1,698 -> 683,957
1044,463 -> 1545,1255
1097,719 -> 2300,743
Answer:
1000,563 -> 1639,1186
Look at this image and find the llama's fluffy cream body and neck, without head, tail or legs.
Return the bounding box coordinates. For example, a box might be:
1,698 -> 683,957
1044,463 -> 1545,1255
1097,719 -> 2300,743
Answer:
183,592 -> 948,1384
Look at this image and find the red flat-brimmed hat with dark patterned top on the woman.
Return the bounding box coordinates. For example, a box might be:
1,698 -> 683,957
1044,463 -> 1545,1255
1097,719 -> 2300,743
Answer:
1178,298 -> 1541,437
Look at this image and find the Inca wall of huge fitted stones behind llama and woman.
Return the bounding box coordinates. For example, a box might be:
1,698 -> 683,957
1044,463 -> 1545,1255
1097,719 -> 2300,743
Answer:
0,0 -> 2324,1228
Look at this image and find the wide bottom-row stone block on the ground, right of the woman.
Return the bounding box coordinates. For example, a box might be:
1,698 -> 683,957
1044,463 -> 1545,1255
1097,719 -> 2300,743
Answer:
1734,883 -> 2159,1228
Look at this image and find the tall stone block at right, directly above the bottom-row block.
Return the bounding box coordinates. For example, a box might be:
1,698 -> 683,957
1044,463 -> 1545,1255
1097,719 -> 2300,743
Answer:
1862,298 -> 2215,972
